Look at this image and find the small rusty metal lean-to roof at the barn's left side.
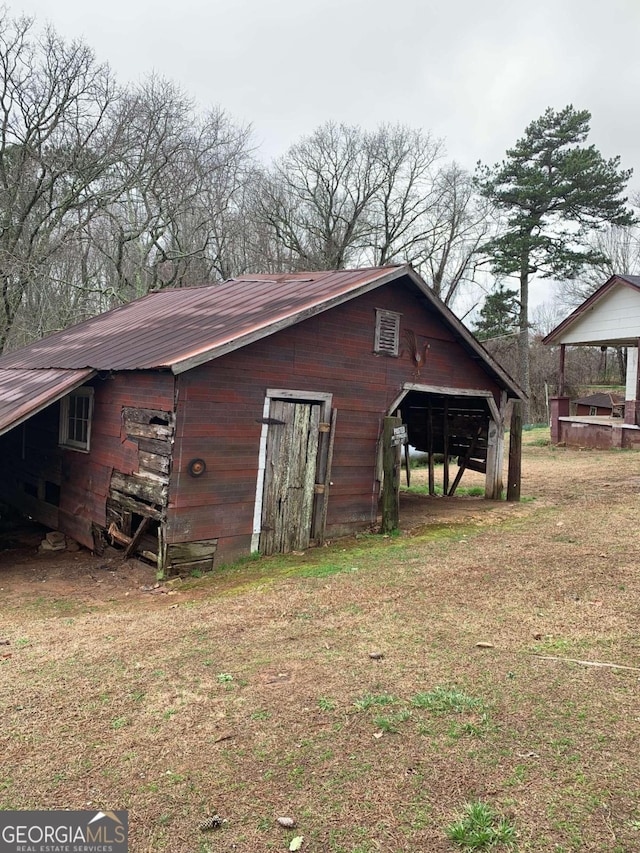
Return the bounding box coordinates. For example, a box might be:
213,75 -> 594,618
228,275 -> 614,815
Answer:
0,368 -> 94,435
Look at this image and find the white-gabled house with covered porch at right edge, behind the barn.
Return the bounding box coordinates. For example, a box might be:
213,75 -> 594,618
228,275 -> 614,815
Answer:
543,275 -> 640,448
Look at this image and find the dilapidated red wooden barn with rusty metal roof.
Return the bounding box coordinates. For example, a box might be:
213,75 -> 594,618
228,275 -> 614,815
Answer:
0,266 -> 522,571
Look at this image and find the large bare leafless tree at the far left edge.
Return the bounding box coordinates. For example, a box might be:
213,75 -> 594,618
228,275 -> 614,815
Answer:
0,14 -> 126,350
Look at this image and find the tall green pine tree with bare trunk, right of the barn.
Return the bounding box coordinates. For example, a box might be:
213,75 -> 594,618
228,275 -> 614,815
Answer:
476,105 -> 634,410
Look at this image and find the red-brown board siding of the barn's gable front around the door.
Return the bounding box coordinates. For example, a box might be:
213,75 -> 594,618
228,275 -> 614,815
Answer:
168,283 -> 499,562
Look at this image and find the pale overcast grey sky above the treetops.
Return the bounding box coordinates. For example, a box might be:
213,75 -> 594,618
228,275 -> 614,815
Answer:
8,0 -> 640,304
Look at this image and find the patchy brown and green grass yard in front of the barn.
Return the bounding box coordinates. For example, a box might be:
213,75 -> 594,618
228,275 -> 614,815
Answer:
0,431 -> 640,853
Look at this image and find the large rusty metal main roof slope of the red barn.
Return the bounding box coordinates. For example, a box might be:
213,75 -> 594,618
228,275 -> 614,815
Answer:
0,266 -> 408,372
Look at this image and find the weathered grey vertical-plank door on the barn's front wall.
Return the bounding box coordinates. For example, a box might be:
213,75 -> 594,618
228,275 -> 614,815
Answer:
260,400 -> 321,554
